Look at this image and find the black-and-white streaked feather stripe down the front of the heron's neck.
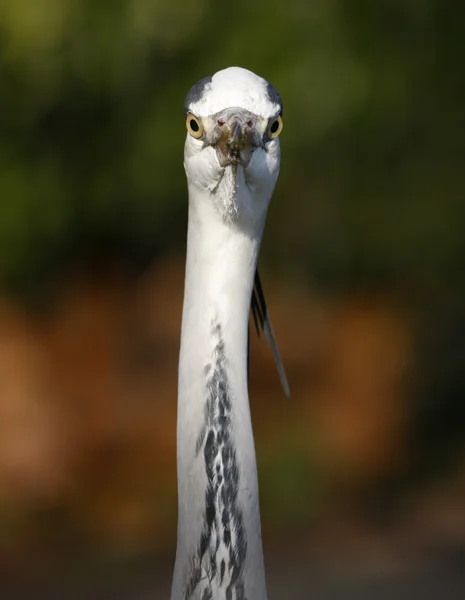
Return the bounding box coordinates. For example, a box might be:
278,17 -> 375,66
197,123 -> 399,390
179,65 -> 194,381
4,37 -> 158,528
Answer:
185,323 -> 247,600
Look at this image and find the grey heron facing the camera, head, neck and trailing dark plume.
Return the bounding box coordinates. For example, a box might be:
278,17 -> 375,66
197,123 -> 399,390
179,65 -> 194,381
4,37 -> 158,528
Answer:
171,67 -> 289,600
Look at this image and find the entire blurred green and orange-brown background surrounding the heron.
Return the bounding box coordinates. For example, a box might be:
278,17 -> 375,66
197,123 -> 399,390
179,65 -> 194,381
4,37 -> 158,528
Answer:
0,0 -> 465,600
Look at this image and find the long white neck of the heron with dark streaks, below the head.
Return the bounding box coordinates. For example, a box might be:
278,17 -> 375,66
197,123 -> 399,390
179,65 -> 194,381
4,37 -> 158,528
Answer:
171,182 -> 267,600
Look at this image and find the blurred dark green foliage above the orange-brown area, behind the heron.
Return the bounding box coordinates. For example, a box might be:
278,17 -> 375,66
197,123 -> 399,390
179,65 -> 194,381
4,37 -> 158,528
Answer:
0,0 -> 465,285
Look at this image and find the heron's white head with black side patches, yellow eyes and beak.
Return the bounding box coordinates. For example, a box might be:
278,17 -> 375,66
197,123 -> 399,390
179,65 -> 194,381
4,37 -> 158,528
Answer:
184,67 -> 283,207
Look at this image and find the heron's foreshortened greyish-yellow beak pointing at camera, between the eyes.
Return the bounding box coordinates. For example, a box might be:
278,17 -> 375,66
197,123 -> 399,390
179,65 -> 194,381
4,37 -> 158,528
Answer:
215,108 -> 260,167
